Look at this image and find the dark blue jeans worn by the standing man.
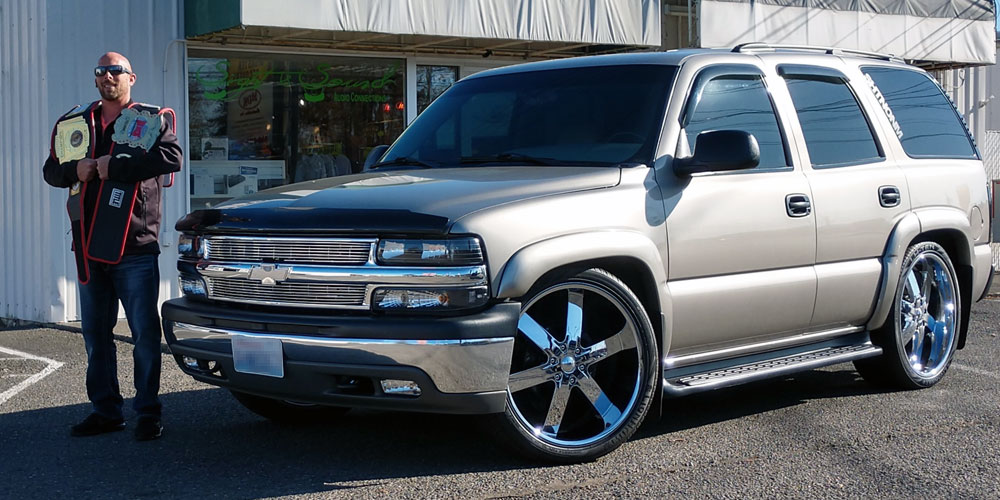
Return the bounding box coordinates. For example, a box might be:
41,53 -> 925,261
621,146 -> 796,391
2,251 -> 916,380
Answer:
80,254 -> 162,419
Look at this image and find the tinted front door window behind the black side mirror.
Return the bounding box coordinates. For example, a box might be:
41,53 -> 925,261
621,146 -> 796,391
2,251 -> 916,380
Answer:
684,75 -> 788,168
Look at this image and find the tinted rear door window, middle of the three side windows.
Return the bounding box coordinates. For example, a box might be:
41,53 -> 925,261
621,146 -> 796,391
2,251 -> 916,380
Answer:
785,75 -> 881,167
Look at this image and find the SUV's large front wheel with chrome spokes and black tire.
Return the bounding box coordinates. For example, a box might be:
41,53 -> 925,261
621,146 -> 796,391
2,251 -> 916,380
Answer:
500,269 -> 659,463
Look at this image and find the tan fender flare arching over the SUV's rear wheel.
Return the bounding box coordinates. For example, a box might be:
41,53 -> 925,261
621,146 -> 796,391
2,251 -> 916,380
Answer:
866,207 -> 973,330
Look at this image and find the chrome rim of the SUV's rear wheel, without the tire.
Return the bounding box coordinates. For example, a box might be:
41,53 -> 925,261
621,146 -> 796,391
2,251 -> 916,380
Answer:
897,251 -> 958,379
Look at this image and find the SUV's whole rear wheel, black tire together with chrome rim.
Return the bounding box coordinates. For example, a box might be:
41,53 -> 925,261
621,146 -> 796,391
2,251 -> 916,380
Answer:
855,242 -> 962,389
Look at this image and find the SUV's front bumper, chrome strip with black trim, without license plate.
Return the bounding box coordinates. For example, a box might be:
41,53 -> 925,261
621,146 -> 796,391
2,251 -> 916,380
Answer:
162,299 -> 520,413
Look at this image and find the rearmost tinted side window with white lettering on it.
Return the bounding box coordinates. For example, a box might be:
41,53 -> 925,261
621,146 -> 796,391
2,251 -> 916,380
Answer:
862,68 -> 976,158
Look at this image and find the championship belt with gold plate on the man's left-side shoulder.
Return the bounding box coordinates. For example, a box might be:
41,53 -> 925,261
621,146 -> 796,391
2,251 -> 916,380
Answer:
52,103 -> 96,284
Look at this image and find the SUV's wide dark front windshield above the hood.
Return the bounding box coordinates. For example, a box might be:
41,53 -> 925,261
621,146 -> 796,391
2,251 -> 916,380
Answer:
379,65 -> 677,167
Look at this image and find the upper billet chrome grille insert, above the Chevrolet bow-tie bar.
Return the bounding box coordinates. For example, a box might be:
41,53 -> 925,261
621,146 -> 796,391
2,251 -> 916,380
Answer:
205,236 -> 375,266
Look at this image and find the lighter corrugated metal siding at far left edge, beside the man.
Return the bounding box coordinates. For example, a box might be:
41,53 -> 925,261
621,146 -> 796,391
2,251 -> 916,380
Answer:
0,0 -> 58,321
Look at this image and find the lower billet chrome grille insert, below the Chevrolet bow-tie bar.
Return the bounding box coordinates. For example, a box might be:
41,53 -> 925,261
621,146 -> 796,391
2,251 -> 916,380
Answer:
205,278 -> 366,307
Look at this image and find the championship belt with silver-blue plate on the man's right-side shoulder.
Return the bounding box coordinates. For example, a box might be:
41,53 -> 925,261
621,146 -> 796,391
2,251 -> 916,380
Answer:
85,103 -> 166,264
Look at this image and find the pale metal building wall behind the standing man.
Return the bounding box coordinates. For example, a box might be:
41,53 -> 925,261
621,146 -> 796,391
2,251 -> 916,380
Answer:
0,0 -> 187,322
